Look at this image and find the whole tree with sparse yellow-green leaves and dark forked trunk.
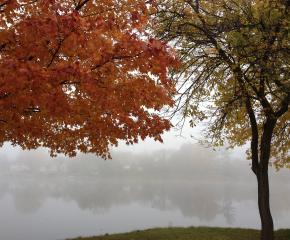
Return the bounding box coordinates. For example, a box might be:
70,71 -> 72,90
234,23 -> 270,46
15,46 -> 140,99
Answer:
155,0 -> 290,240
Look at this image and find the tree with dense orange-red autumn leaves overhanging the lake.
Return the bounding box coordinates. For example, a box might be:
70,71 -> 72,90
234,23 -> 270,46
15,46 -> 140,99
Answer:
0,0 -> 179,157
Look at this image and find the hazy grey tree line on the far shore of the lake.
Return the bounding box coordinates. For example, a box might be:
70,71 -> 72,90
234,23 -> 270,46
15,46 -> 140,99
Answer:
0,143 -> 285,179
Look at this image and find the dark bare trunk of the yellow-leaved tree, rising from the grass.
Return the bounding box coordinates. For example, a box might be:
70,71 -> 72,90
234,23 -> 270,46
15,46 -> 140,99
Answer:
252,118 -> 276,240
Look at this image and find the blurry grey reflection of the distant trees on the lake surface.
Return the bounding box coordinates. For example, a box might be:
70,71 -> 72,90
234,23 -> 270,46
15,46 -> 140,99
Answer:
0,178 -> 290,240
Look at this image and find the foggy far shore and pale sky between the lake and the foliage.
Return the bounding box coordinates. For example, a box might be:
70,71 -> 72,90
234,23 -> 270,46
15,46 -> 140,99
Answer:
0,124 -> 290,182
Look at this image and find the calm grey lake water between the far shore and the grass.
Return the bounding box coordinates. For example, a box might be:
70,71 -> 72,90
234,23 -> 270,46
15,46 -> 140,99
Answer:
0,178 -> 290,240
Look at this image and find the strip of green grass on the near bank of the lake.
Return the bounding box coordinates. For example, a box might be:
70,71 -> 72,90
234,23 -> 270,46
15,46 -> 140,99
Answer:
67,227 -> 290,240
